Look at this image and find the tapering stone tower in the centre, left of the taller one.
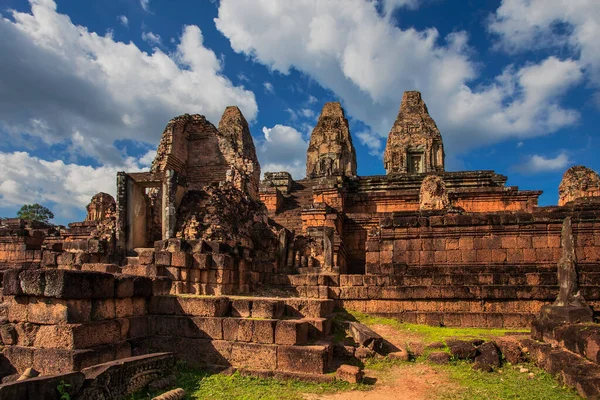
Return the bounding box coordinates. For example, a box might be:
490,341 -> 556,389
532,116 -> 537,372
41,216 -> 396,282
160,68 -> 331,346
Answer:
306,102 -> 356,178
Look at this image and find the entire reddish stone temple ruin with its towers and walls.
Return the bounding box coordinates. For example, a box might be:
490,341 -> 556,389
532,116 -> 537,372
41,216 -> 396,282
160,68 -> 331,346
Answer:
0,92 -> 600,398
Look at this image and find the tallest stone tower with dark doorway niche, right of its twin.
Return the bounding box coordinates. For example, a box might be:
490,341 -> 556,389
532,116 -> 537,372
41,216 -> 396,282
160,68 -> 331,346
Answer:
383,91 -> 444,174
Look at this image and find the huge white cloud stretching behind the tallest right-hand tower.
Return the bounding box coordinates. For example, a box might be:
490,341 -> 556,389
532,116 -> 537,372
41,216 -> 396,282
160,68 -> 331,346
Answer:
215,0 -> 584,156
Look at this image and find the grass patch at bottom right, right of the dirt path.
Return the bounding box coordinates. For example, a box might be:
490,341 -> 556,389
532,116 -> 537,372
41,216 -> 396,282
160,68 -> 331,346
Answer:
434,361 -> 581,400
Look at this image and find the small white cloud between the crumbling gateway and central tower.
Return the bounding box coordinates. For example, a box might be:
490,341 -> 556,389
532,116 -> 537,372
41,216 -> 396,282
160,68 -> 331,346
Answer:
257,124 -> 308,179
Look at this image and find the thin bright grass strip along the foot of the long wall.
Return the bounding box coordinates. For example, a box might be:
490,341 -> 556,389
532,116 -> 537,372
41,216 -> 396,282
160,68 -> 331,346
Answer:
345,311 -> 529,343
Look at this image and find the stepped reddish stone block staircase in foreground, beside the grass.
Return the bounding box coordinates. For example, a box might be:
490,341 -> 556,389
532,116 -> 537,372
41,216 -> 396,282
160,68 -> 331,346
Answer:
138,296 -> 334,375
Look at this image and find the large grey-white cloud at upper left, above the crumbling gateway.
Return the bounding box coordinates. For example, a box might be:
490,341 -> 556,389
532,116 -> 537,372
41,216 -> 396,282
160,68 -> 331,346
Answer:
0,0 -> 258,165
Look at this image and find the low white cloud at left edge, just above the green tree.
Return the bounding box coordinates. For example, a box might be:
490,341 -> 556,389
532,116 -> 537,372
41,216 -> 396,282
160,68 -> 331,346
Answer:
0,151 -> 145,212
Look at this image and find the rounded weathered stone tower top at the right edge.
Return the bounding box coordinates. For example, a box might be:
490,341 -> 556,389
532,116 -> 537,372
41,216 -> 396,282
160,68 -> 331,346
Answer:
558,165 -> 600,206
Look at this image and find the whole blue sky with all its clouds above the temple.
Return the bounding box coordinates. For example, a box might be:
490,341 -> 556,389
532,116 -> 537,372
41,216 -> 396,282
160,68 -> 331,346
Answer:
0,0 -> 600,223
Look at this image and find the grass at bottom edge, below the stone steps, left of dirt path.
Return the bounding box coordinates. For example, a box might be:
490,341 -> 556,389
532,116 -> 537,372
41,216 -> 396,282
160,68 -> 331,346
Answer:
127,366 -> 370,400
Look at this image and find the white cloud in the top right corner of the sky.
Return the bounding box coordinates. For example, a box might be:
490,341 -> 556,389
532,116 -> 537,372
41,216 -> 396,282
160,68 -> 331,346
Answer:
488,0 -> 600,90
